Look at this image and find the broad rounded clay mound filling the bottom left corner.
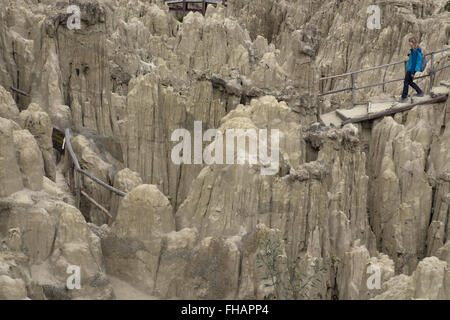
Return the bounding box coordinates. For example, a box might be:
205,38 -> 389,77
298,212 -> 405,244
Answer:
0,189 -> 112,299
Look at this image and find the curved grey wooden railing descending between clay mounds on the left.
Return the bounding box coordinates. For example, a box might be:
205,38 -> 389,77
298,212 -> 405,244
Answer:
64,128 -> 126,218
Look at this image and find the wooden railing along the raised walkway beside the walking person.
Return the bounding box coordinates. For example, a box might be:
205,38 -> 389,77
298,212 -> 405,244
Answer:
319,47 -> 450,105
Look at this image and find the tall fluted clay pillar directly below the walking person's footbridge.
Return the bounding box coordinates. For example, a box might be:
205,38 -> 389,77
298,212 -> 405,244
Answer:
371,118 -> 432,272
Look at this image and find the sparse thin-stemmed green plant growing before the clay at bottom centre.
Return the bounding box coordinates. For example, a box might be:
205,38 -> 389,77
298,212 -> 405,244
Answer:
256,232 -> 328,300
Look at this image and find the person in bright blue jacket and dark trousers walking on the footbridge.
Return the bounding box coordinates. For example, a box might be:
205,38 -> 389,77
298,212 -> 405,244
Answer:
400,37 -> 424,103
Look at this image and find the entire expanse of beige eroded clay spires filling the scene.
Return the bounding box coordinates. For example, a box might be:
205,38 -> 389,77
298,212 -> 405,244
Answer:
0,0 -> 450,299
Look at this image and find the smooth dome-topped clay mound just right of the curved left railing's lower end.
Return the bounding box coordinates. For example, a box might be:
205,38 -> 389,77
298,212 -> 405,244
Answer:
102,184 -> 175,290
